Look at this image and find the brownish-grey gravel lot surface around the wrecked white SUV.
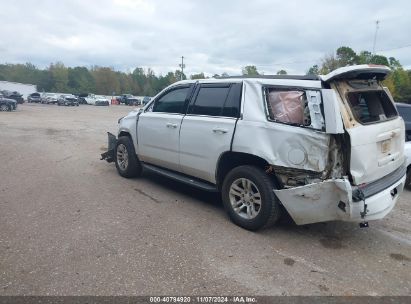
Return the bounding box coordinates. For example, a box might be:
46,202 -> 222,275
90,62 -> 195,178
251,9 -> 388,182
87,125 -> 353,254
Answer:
0,104 -> 411,295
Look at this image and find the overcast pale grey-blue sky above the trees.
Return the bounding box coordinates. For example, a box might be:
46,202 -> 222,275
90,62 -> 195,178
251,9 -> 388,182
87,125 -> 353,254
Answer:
0,0 -> 411,75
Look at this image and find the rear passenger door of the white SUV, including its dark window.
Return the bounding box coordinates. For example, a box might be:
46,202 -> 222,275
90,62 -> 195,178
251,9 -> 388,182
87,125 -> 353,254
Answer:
180,83 -> 242,182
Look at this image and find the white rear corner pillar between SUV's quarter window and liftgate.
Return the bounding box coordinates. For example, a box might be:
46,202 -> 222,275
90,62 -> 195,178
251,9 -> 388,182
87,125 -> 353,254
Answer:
321,89 -> 344,134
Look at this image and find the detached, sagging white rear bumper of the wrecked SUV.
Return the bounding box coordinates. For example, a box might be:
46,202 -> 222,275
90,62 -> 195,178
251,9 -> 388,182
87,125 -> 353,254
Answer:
274,165 -> 406,225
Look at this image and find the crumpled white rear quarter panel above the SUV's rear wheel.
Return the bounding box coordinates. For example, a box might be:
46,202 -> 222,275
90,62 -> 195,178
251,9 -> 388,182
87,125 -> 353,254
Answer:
232,79 -> 330,172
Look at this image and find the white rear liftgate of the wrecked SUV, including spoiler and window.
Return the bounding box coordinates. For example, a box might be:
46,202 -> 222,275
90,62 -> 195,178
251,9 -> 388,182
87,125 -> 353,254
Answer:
322,65 -> 404,185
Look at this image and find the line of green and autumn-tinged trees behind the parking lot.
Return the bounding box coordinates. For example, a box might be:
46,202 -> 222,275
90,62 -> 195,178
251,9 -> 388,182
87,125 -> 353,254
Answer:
0,46 -> 411,103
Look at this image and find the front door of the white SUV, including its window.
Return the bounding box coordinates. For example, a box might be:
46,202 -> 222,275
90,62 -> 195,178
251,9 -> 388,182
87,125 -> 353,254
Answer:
137,85 -> 192,171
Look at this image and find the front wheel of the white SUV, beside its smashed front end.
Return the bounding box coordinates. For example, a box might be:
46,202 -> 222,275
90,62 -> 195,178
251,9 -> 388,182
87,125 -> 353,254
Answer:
114,136 -> 142,178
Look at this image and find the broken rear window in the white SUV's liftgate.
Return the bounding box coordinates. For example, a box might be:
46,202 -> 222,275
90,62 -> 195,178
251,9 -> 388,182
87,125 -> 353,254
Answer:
347,90 -> 398,124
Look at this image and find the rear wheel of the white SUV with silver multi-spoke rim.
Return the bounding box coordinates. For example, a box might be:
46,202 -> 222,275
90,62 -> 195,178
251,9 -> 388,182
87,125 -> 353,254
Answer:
221,166 -> 281,231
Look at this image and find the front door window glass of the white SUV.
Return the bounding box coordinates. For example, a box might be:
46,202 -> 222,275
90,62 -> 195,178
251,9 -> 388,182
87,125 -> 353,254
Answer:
152,87 -> 190,113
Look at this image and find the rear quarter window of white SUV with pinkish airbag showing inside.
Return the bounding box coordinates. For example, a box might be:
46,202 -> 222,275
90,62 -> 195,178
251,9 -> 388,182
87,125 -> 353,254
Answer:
265,89 -> 324,130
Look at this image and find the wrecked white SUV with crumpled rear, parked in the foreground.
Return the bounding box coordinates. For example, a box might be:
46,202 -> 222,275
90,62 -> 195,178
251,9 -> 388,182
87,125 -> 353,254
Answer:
102,65 -> 406,230
